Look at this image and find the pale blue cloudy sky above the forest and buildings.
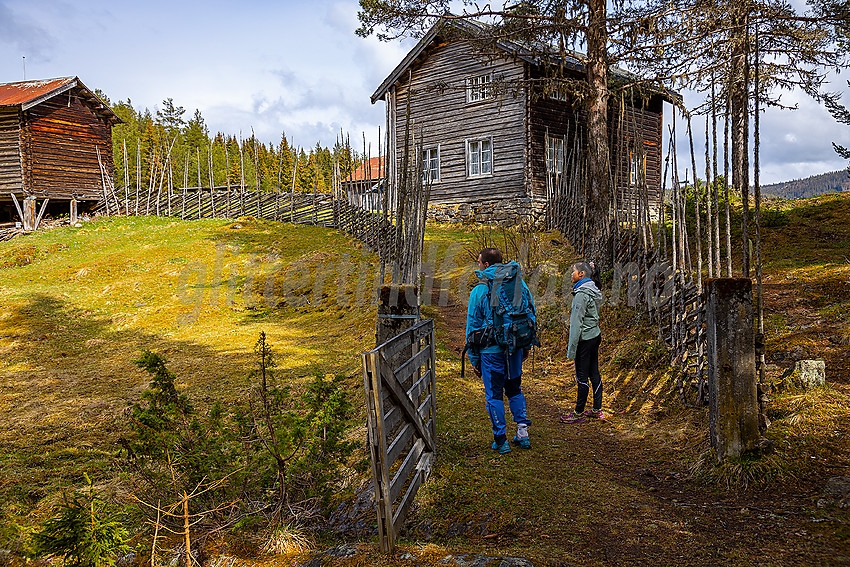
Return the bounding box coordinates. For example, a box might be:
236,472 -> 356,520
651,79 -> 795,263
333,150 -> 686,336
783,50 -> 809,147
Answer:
0,0 -> 850,184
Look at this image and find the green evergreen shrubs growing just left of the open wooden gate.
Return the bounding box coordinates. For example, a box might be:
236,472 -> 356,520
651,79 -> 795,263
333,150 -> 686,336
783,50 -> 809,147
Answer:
122,333 -> 355,527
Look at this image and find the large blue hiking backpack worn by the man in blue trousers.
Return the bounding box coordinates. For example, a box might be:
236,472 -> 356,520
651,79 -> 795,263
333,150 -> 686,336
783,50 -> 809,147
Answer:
460,262 -> 540,377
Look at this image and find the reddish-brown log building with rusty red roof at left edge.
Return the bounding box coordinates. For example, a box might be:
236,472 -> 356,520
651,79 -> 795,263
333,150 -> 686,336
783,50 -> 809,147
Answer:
0,77 -> 121,221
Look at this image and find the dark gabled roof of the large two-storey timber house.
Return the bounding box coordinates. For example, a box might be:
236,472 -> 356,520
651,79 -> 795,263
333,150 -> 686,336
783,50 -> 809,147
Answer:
371,18 -> 679,104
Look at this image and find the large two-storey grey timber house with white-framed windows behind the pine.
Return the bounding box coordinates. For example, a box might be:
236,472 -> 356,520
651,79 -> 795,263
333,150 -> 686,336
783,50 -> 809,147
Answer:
372,20 -> 676,221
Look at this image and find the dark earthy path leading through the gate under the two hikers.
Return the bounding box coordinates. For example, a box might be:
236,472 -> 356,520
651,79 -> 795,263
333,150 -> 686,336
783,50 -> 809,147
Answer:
430,296 -> 850,565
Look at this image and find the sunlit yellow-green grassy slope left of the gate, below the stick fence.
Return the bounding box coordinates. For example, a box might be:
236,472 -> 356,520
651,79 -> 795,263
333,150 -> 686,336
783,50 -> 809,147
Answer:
0,218 -> 375,512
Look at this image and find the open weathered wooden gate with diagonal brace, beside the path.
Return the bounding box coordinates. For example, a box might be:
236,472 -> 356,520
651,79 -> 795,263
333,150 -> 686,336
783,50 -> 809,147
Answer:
363,319 -> 437,553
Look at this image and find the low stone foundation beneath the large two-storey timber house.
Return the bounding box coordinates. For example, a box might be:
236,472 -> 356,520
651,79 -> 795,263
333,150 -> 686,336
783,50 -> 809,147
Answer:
428,197 -> 545,227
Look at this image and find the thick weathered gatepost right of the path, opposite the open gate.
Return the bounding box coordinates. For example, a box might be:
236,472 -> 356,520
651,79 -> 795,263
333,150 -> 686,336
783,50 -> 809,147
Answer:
705,278 -> 759,461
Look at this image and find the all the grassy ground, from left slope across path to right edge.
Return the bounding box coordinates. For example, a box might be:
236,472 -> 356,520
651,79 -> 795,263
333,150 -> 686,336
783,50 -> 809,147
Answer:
0,197 -> 850,565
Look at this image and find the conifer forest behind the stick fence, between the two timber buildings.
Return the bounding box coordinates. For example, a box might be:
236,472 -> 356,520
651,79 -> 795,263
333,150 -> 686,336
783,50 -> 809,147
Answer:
97,91 -> 363,197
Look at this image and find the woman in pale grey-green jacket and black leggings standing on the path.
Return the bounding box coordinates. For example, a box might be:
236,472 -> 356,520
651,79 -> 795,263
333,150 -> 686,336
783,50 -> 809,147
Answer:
561,262 -> 605,423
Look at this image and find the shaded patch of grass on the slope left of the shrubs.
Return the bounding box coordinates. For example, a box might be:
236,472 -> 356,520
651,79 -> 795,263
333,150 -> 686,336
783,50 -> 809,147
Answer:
0,294 -> 358,510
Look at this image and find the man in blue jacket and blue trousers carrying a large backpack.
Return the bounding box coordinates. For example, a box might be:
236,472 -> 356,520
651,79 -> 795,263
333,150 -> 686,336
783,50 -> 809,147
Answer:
464,248 -> 539,454
